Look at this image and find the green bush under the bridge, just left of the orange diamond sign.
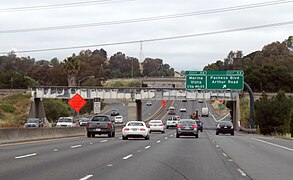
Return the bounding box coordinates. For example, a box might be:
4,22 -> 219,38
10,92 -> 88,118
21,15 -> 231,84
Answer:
44,99 -> 70,122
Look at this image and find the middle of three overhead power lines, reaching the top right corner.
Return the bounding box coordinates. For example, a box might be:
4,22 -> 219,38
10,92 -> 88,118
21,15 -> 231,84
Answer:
0,0 -> 293,34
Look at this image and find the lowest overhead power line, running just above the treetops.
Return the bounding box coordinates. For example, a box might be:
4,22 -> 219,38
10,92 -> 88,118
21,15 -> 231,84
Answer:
0,21 -> 293,54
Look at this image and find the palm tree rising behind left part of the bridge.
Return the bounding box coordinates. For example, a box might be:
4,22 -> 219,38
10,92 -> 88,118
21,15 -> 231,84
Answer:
64,54 -> 80,86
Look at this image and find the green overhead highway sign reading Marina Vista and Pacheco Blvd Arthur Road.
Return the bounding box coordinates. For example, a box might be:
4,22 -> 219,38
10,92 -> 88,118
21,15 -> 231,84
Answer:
186,71 -> 244,90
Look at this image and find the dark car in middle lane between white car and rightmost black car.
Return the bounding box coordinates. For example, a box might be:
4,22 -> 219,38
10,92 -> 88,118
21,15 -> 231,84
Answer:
176,119 -> 198,138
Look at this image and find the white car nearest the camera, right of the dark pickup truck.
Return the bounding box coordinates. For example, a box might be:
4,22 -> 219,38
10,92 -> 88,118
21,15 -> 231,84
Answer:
122,121 -> 150,140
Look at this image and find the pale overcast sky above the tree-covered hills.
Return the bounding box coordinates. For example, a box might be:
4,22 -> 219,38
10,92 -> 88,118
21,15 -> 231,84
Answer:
0,0 -> 293,71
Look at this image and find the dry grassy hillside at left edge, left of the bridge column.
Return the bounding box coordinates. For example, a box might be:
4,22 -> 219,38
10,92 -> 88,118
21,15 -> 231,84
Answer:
0,93 -> 31,127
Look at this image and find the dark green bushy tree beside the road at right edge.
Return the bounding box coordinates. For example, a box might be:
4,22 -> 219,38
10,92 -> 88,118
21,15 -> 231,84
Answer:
255,91 -> 292,134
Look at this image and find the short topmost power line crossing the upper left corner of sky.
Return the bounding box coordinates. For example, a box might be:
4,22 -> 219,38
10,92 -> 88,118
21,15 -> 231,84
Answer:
0,0 -> 135,12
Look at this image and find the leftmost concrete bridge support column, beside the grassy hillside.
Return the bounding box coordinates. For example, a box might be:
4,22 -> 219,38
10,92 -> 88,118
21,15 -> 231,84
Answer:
29,97 -> 47,124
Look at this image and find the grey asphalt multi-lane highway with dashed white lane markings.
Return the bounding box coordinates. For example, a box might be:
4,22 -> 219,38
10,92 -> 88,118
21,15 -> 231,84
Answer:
0,101 -> 293,180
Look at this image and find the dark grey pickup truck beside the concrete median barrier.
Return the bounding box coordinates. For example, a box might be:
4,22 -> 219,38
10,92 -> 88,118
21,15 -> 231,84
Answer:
86,115 -> 115,137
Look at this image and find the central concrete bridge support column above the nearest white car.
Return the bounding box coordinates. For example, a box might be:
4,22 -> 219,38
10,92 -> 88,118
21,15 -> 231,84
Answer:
128,100 -> 142,121
